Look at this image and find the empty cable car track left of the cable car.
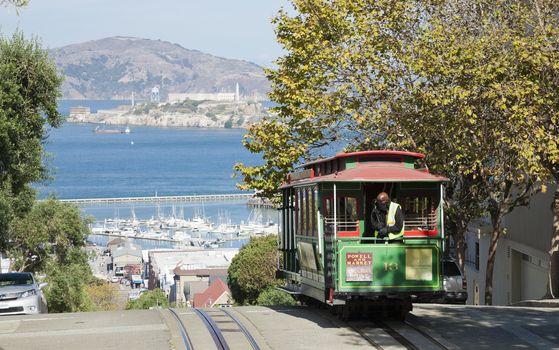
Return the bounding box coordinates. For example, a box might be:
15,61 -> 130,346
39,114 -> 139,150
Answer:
169,309 -> 260,350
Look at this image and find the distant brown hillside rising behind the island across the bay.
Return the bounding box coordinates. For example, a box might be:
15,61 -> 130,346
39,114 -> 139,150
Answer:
50,37 -> 269,100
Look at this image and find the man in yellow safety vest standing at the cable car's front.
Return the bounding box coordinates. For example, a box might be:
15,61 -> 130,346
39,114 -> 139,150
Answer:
371,192 -> 404,239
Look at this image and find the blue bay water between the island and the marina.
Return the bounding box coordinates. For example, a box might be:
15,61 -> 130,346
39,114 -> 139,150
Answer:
35,100 -> 278,248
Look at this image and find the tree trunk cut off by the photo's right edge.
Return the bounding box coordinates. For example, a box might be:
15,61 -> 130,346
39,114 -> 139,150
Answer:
546,182 -> 559,299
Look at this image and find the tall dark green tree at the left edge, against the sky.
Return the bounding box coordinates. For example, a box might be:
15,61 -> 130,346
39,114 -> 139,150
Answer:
0,32 -> 63,250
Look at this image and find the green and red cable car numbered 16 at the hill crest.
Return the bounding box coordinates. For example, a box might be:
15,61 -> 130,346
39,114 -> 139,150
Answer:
279,151 -> 447,318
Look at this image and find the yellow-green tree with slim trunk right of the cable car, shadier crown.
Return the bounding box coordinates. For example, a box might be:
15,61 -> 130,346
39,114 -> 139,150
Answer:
399,0 -> 535,304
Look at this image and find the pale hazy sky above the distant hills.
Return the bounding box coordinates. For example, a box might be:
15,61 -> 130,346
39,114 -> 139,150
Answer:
0,0 -> 291,66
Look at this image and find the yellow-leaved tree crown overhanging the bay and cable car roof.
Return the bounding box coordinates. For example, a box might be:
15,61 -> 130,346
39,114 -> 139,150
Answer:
235,0 -> 421,197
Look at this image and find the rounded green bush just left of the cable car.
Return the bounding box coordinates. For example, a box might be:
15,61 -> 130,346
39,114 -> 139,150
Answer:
227,235 -> 280,305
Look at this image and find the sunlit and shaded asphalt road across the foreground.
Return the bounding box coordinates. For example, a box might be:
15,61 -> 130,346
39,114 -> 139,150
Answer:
0,304 -> 559,350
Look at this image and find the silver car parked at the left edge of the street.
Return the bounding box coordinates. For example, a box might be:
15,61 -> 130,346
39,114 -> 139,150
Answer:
0,272 -> 48,315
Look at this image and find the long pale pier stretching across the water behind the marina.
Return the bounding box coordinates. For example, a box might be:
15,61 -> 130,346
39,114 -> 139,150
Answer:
60,193 -> 254,205
